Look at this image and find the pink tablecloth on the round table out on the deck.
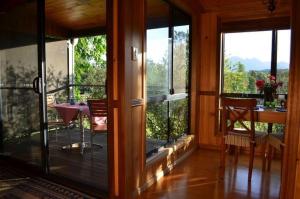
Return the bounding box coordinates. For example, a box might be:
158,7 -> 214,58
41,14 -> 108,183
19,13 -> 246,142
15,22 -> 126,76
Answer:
54,103 -> 90,125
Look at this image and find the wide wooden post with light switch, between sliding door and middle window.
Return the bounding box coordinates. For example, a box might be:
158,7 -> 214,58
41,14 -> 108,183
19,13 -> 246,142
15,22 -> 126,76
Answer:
110,0 -> 145,199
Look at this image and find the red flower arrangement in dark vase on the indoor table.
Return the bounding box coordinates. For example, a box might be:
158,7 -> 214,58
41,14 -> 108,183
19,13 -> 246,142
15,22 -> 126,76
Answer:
256,75 -> 283,102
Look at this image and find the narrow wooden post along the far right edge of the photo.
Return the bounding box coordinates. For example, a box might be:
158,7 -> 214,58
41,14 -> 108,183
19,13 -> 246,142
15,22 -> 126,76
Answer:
281,0 -> 300,199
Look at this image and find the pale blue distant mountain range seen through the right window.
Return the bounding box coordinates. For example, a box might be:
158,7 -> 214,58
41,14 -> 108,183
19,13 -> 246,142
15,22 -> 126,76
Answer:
229,56 -> 289,71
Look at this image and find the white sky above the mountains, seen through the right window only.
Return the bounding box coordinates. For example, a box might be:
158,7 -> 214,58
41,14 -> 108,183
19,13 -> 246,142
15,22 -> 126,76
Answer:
225,30 -> 290,63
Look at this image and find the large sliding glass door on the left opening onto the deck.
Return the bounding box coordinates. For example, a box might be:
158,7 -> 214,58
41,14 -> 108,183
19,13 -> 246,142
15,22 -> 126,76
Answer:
0,0 -> 109,192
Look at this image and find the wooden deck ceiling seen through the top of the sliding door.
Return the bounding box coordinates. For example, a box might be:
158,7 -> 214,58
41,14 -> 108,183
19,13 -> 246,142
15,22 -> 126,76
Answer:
46,0 -> 106,31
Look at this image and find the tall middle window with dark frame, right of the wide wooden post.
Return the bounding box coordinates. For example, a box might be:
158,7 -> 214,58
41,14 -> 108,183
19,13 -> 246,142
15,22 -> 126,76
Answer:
146,0 -> 190,157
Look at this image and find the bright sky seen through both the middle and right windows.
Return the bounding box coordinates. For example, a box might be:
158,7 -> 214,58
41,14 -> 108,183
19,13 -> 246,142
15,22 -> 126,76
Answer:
147,27 -> 290,68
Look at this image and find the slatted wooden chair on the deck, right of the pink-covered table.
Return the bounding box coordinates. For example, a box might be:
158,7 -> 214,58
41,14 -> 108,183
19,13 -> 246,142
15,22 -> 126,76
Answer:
87,99 -> 108,152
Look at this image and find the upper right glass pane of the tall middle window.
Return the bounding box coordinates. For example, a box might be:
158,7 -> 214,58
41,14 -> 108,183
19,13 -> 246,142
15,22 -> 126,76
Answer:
173,25 -> 190,93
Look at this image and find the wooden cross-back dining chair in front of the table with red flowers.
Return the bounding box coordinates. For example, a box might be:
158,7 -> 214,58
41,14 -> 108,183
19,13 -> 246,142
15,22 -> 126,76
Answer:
220,97 -> 268,181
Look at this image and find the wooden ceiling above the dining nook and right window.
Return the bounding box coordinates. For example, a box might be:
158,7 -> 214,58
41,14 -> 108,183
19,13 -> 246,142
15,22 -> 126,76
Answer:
197,0 -> 291,21
